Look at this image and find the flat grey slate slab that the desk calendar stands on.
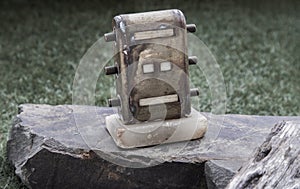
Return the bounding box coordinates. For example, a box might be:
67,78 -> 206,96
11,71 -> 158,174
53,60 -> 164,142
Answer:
7,104 -> 300,188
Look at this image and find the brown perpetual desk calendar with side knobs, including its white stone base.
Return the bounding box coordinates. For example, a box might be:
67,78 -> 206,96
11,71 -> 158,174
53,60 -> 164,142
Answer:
104,9 -> 207,148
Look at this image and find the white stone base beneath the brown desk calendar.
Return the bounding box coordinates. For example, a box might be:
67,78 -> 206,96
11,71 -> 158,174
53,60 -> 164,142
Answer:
106,109 -> 207,148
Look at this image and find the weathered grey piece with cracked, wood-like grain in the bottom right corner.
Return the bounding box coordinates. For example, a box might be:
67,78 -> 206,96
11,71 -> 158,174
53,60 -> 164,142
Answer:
227,121 -> 300,189
